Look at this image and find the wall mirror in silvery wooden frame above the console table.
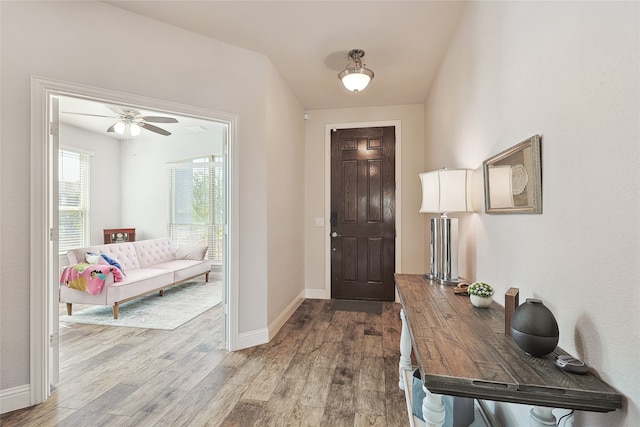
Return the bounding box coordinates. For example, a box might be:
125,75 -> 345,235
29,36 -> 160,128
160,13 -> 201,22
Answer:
482,135 -> 542,214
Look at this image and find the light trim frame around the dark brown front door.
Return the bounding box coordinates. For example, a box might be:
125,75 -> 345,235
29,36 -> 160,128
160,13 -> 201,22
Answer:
324,120 -> 402,302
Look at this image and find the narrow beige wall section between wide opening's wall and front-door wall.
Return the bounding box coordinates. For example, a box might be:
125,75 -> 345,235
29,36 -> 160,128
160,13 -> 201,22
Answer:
267,61 -> 305,331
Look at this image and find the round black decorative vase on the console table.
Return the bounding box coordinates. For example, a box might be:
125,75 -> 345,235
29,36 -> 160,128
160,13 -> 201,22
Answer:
511,298 -> 560,356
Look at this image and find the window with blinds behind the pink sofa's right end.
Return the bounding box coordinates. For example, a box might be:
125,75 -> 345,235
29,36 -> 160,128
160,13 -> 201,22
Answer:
169,155 -> 224,264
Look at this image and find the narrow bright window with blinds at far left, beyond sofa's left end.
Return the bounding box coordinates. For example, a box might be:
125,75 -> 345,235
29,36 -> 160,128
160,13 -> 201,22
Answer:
58,149 -> 90,254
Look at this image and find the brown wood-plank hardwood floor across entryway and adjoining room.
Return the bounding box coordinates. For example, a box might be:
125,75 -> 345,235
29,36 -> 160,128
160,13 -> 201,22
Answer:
0,300 -> 408,427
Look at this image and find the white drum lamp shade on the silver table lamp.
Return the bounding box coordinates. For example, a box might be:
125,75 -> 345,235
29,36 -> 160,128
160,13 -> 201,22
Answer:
420,169 -> 473,213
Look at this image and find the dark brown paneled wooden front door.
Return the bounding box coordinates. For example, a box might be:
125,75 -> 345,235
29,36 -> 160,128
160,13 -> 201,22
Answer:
330,126 -> 396,301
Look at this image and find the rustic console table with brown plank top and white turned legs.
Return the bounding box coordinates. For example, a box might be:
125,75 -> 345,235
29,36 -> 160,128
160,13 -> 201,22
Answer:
395,274 -> 622,426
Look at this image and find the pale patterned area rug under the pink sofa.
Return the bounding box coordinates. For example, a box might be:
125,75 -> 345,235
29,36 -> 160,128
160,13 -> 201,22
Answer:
60,282 -> 222,331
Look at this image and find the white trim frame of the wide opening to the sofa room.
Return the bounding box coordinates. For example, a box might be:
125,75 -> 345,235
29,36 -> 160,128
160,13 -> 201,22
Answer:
29,76 -> 239,405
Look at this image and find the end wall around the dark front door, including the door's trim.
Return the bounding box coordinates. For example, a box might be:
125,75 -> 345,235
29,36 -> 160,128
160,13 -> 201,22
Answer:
304,105 -> 425,295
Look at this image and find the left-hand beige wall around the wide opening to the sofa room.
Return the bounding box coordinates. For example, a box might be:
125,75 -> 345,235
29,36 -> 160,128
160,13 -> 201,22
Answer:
0,1 -> 304,402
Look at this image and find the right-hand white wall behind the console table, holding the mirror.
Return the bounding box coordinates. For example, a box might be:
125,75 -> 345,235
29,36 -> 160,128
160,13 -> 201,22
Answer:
425,2 -> 640,427
